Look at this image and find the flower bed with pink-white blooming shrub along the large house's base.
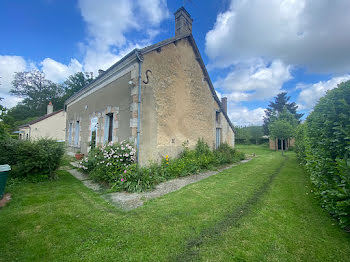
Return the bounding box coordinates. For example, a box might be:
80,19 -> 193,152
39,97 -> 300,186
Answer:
81,139 -> 245,192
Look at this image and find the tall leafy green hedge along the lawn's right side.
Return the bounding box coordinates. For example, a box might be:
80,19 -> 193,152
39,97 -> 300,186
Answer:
296,81 -> 350,230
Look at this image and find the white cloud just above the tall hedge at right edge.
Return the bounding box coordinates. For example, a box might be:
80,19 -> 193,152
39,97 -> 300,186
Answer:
297,75 -> 350,110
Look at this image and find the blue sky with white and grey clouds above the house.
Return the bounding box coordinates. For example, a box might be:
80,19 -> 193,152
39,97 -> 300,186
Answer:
0,0 -> 350,125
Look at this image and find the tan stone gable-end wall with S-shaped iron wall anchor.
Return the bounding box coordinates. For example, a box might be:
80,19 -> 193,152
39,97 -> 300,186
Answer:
140,39 -> 234,165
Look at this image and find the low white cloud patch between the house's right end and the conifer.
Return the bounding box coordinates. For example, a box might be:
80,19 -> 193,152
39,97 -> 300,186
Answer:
228,105 -> 265,126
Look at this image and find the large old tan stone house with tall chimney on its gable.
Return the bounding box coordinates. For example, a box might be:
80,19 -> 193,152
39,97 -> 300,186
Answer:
65,7 -> 235,165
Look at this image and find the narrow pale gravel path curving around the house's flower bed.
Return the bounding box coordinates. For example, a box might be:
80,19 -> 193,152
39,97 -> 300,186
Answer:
67,158 -> 252,210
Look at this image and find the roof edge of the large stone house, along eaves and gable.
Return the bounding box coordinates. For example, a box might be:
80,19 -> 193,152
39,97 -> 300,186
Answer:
65,33 -> 236,132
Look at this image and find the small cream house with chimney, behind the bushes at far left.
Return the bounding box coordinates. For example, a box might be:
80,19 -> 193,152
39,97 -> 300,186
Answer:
18,102 -> 66,142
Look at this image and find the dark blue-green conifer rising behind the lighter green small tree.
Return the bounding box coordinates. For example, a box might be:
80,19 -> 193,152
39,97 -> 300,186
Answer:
263,92 -> 304,135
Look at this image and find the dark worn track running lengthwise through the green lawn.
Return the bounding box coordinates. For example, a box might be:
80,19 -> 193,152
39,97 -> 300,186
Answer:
174,156 -> 288,261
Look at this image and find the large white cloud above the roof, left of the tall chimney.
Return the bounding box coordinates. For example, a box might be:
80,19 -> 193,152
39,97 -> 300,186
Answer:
79,0 -> 169,74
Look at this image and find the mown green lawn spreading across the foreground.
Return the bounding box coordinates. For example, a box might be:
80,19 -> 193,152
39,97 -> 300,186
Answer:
0,146 -> 350,261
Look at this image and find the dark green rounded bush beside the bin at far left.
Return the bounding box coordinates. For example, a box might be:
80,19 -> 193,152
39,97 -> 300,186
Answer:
0,138 -> 64,180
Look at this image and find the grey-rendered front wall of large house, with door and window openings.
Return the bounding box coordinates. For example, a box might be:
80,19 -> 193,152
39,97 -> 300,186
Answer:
66,70 -> 136,154
